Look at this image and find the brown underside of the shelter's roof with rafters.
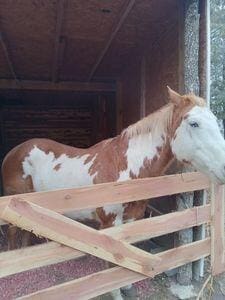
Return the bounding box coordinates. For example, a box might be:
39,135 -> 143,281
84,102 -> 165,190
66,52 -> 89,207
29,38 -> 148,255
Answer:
0,0 -> 177,82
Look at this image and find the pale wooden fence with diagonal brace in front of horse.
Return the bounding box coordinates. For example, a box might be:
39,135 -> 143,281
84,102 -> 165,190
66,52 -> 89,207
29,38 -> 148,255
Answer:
0,172 -> 225,300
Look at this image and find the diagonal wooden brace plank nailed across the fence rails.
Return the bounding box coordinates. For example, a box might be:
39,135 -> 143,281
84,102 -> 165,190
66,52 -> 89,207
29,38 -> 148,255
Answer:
2,199 -> 160,276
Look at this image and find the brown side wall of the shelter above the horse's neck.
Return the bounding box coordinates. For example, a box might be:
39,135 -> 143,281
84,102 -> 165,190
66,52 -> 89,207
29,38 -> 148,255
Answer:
119,3 -> 179,128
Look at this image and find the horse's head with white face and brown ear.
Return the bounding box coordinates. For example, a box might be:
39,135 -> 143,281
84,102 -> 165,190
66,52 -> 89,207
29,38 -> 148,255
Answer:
168,88 -> 225,184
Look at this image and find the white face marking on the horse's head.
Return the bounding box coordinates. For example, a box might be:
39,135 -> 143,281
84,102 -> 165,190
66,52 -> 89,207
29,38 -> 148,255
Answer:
171,106 -> 225,183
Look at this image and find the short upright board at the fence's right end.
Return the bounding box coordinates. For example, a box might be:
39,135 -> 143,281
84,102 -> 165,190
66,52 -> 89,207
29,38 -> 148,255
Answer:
211,184 -> 225,275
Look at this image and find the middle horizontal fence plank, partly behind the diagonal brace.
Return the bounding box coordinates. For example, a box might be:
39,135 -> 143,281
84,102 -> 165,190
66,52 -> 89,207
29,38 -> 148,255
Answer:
0,205 -> 210,278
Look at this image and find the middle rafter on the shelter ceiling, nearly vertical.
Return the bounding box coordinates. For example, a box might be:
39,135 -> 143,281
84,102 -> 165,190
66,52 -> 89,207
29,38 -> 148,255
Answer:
52,0 -> 66,82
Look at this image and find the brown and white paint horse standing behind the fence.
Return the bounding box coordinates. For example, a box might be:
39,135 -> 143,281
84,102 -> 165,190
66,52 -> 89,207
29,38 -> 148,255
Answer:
2,87 -> 225,298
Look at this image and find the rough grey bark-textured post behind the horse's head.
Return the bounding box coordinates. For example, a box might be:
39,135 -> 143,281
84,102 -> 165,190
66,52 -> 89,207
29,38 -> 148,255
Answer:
176,0 -> 199,285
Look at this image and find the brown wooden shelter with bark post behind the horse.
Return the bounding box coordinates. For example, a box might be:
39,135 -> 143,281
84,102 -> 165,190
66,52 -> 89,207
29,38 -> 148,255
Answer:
0,0 -> 214,298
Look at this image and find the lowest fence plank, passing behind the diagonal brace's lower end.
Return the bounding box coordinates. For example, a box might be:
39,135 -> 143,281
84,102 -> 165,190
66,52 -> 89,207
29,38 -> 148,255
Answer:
19,238 -> 210,300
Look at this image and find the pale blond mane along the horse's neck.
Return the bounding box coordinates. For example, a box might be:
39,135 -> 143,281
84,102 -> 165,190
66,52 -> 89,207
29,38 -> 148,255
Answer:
122,103 -> 174,138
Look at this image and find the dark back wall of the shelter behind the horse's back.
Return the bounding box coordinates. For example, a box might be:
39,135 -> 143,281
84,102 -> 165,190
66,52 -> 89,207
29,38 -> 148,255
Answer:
0,92 -> 115,161
